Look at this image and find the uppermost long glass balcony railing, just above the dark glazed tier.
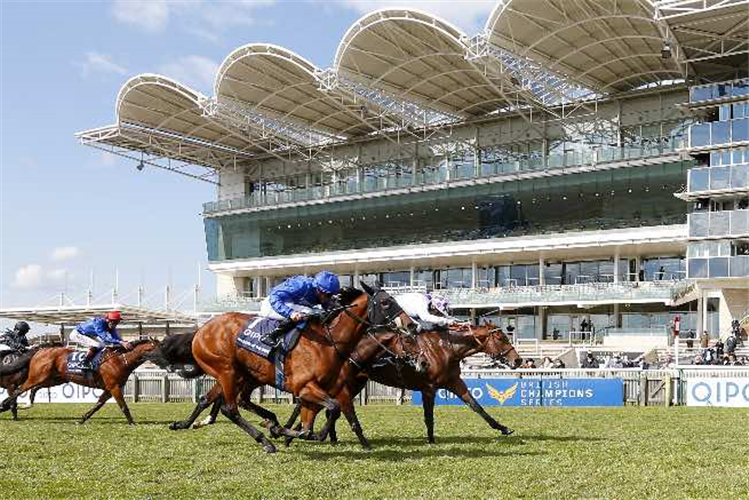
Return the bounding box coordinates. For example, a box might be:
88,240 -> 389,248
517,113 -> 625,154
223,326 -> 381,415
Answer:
203,138 -> 681,215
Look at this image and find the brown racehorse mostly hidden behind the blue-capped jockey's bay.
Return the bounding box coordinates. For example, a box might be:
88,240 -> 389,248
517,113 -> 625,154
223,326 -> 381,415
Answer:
186,330 -> 418,449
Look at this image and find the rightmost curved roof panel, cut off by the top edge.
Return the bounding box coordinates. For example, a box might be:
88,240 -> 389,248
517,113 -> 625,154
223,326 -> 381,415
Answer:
486,0 -> 683,92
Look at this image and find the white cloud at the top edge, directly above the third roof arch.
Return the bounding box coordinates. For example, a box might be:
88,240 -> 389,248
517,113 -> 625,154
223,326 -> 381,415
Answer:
330,0 -> 497,35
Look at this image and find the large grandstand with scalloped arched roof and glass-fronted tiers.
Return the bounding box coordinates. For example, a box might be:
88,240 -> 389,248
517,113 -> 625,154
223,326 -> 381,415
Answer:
78,0 -> 749,352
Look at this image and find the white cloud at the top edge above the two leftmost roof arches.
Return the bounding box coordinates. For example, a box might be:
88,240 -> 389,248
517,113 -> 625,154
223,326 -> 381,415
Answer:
112,0 -> 275,42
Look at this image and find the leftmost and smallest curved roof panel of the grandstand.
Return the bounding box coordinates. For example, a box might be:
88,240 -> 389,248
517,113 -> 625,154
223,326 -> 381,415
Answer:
116,74 -> 247,150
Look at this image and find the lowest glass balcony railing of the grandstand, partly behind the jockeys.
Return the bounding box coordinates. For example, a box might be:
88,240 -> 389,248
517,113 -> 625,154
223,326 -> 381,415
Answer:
201,280 -> 689,313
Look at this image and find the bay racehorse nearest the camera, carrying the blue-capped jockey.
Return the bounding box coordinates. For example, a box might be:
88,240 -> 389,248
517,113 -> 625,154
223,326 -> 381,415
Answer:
149,283 -> 412,453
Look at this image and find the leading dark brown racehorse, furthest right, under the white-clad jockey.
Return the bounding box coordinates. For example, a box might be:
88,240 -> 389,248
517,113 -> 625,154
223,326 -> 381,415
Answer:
286,322 -> 521,445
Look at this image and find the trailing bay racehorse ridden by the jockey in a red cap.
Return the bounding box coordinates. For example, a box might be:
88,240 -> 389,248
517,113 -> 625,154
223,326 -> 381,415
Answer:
0,339 -> 159,425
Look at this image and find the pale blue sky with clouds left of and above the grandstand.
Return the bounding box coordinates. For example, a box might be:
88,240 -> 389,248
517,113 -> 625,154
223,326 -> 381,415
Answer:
0,0 -> 496,318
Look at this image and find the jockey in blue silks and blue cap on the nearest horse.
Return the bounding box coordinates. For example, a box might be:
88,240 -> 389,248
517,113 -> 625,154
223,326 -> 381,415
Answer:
260,271 -> 341,345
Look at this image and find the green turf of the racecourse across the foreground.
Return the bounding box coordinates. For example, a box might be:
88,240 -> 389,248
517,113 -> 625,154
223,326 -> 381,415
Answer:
0,403 -> 749,500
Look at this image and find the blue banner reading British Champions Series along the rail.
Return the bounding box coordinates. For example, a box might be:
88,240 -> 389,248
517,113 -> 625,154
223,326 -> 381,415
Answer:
413,378 -> 624,406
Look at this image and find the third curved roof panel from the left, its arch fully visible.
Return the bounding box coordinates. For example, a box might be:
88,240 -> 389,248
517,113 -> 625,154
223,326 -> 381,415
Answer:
334,9 -> 507,117
